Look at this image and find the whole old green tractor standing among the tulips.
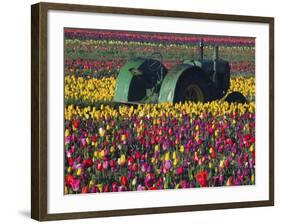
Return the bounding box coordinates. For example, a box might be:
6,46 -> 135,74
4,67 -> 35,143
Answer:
113,39 -> 247,104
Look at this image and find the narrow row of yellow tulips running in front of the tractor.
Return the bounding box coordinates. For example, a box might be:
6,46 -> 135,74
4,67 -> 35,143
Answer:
64,101 -> 255,121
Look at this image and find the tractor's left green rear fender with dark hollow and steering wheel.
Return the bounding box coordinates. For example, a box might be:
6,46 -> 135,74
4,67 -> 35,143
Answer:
113,53 -> 168,103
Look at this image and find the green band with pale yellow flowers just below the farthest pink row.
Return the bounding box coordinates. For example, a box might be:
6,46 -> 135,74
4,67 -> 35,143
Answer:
65,40 -> 255,61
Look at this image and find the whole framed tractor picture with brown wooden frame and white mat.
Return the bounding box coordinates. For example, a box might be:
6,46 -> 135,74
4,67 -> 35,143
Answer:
31,3 -> 274,221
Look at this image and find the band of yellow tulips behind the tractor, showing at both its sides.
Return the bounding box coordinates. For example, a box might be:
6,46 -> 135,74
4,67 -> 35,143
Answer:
64,76 -> 255,102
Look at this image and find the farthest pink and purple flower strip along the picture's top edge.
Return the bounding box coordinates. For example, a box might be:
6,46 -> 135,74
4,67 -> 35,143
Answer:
64,29 -> 255,46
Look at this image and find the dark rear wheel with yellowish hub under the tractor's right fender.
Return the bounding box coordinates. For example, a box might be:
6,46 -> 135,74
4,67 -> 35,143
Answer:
175,74 -> 210,102
